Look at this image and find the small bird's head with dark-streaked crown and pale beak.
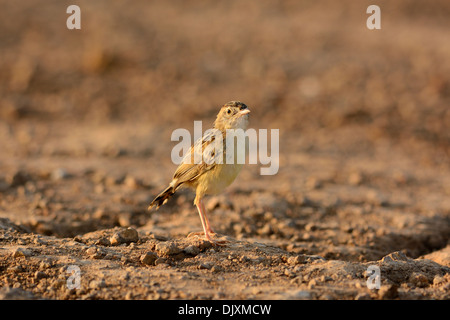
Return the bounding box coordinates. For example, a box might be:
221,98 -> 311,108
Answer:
214,101 -> 250,130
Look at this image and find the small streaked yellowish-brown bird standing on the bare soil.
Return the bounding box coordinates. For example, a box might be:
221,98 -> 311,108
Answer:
148,101 -> 250,242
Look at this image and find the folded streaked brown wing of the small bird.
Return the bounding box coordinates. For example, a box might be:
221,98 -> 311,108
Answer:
173,129 -> 224,188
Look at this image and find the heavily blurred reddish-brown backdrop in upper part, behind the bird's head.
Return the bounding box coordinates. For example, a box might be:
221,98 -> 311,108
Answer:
0,0 -> 450,152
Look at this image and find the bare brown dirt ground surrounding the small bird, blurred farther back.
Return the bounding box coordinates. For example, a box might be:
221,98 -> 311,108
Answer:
0,0 -> 450,300
